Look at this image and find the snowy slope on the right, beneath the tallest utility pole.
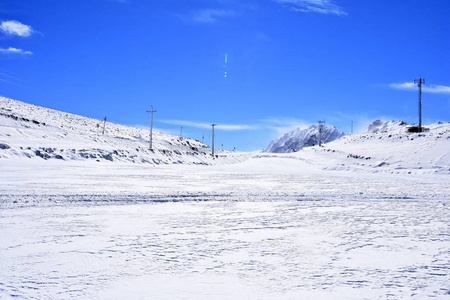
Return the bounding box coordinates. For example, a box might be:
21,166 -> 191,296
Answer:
253,121 -> 450,174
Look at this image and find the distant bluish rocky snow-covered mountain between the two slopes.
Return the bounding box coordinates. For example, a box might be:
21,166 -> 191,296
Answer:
263,125 -> 345,153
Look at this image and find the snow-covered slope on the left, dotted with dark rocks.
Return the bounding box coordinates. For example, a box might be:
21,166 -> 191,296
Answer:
0,97 -> 248,165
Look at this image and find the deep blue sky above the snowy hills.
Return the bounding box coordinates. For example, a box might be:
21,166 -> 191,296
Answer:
0,0 -> 450,151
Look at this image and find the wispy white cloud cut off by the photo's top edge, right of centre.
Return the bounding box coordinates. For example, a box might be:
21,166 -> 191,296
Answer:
273,0 -> 347,16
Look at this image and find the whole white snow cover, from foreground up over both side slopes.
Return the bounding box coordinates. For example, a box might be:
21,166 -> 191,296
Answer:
0,97 -> 450,299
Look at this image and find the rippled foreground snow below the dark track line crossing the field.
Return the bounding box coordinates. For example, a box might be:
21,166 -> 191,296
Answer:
0,199 -> 450,299
